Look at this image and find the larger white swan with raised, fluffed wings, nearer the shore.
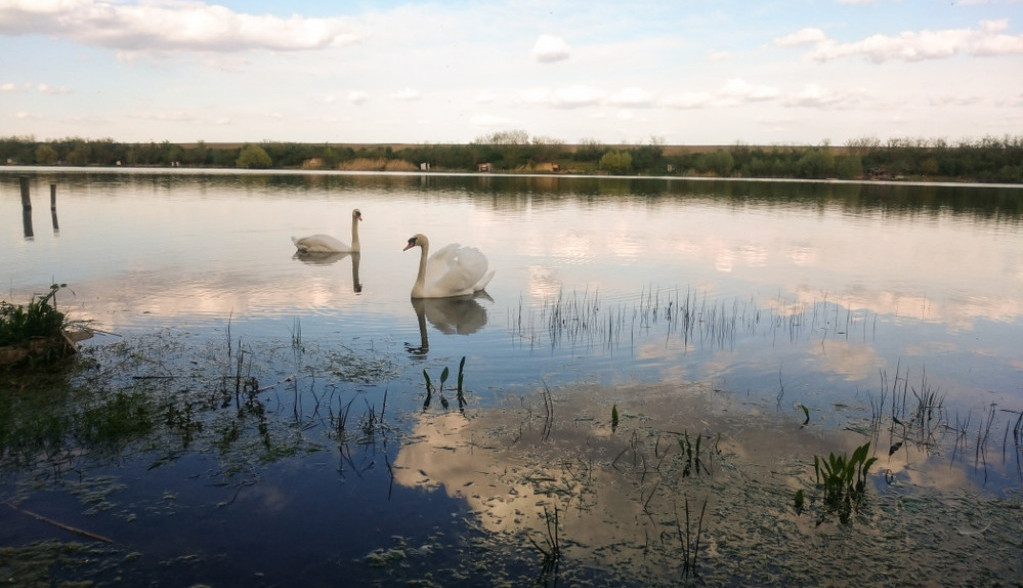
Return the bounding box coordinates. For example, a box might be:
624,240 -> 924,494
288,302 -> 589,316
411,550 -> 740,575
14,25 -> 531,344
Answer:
402,233 -> 494,299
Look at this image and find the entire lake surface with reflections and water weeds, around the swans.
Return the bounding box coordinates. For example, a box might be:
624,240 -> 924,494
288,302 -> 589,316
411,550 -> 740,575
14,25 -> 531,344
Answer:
0,168 -> 1023,586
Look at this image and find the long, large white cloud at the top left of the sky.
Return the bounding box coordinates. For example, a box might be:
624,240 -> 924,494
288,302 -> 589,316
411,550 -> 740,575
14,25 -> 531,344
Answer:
0,0 -> 364,52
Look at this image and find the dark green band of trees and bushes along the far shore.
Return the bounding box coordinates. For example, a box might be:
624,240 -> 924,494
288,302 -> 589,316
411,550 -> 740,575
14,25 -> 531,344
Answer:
0,131 -> 1023,183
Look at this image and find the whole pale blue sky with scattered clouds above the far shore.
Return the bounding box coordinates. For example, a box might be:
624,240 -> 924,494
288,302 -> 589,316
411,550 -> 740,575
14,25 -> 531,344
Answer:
0,0 -> 1023,145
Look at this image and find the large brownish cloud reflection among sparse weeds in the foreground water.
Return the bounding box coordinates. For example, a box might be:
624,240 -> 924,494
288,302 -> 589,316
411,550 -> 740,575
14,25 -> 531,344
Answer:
394,385 -> 990,572
